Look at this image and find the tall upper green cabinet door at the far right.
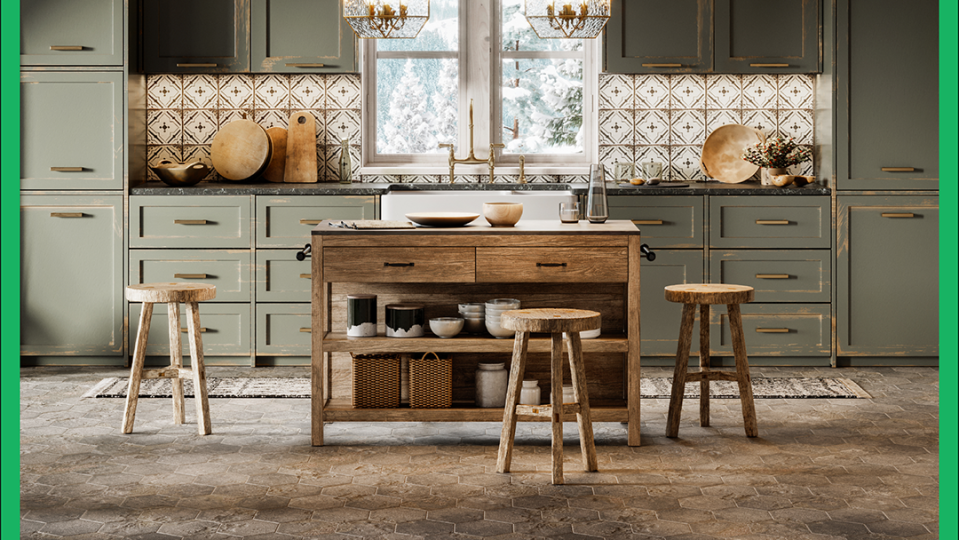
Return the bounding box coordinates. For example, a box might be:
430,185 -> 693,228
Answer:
836,0 -> 939,190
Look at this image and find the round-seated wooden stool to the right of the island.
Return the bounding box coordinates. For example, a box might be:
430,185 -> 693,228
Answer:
666,283 -> 759,437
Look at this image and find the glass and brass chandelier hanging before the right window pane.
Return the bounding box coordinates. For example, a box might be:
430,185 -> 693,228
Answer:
525,0 -> 610,39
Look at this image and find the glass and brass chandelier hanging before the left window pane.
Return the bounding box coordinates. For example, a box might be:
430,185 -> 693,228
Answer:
343,0 -> 430,38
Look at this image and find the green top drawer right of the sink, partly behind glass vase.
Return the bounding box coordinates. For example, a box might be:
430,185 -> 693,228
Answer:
609,195 -> 703,248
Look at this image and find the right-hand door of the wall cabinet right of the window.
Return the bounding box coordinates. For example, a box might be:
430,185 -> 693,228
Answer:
715,0 -> 820,73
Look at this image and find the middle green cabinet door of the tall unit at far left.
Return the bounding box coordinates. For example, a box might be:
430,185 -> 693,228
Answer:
20,71 -> 125,190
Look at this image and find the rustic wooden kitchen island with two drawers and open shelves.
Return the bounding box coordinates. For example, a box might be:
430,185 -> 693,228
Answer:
314,220 -> 641,446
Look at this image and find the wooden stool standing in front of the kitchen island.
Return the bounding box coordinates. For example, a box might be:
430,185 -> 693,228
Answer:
496,309 -> 600,484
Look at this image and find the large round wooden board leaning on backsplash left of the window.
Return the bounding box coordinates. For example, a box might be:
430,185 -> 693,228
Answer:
210,120 -> 270,180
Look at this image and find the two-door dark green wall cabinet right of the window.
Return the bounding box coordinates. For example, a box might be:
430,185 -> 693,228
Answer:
605,0 -> 821,73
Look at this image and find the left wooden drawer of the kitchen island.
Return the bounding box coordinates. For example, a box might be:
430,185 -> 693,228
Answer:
323,248 -> 476,283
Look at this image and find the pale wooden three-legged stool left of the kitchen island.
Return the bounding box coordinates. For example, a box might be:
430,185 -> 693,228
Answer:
123,283 -> 216,435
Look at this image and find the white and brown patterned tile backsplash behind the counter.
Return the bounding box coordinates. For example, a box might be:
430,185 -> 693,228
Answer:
147,74 -> 814,183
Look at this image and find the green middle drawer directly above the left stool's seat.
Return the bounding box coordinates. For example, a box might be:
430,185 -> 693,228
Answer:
130,249 -> 252,302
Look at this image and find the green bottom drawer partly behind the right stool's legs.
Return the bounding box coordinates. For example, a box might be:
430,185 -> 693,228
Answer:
709,304 -> 832,356
